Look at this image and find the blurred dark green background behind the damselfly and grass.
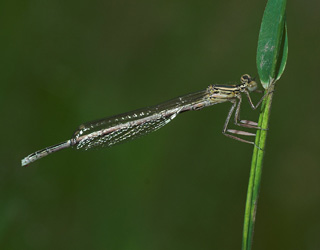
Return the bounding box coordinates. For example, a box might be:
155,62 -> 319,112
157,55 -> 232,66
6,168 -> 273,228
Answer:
0,0 -> 320,250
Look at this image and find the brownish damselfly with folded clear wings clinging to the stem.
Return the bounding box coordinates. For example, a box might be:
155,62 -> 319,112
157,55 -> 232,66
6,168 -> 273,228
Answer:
21,74 -> 264,166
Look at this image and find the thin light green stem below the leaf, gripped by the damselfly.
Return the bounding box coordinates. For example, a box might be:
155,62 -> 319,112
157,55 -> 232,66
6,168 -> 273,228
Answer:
242,84 -> 274,250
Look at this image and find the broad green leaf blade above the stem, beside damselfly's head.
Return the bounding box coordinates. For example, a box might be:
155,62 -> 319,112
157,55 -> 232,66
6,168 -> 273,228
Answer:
257,0 -> 288,89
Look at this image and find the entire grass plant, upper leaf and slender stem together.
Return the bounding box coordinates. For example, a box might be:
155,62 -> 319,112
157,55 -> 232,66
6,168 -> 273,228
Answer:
242,0 -> 288,250
